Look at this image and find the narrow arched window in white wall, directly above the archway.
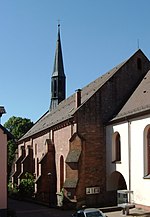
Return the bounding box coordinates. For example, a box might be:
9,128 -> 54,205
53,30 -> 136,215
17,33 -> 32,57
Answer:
112,132 -> 121,162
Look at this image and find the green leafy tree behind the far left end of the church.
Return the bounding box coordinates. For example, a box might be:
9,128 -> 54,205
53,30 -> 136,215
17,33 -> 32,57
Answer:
4,116 -> 33,173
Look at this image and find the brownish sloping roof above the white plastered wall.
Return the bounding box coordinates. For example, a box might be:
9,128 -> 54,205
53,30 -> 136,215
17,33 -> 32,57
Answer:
112,71 -> 150,121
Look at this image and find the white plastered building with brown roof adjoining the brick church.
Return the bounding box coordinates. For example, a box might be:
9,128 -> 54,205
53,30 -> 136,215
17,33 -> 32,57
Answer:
106,71 -> 150,208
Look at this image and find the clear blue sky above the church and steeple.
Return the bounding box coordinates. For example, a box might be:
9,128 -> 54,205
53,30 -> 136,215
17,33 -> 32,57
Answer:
0,0 -> 150,124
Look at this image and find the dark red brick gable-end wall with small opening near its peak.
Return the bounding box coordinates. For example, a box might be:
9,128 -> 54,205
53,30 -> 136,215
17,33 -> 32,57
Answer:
76,52 -> 150,205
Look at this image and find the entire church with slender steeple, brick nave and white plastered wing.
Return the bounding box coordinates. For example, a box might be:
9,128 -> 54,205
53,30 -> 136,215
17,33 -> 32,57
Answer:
12,26 -> 150,208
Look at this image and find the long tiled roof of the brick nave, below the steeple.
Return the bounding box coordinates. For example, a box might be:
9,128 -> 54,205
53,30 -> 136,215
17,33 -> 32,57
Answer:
20,61 -> 126,141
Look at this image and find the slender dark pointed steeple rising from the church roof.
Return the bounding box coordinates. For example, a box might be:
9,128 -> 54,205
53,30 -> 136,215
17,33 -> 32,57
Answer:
50,24 -> 66,110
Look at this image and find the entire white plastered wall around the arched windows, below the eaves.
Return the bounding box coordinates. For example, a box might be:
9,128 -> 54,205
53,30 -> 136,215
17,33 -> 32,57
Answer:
106,117 -> 150,206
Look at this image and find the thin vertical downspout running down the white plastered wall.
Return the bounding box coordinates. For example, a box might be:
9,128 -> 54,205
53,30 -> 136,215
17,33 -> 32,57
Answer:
128,121 -> 131,203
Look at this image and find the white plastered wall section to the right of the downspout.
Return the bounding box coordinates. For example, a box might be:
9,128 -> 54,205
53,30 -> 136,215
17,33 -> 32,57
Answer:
131,117 -> 150,206
